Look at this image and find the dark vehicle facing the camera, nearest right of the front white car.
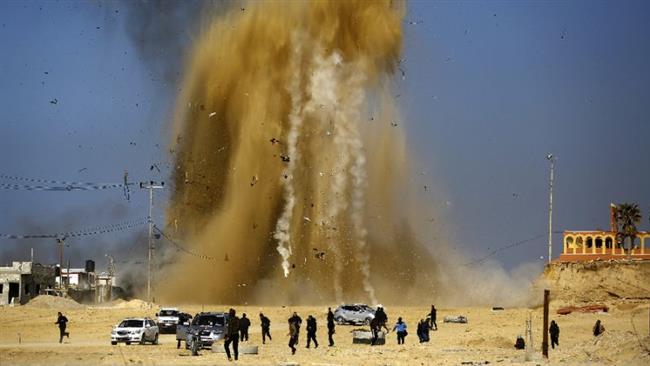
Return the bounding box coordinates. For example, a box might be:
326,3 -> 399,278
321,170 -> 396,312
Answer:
176,312 -> 228,348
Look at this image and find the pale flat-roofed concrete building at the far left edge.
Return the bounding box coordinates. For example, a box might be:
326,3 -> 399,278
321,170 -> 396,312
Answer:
0,262 -> 55,305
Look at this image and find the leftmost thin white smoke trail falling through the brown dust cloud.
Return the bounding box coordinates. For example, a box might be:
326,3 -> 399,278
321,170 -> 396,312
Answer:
273,35 -> 303,277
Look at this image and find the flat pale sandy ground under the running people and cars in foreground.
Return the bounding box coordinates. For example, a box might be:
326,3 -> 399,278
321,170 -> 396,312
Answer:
0,301 -> 650,366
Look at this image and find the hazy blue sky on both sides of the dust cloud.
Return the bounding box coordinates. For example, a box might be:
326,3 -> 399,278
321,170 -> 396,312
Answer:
0,1 -> 650,268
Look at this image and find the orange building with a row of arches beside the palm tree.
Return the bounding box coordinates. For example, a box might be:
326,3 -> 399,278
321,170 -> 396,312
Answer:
558,205 -> 650,262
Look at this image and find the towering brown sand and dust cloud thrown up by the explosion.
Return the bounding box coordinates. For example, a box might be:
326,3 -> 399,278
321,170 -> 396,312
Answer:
157,1 -> 536,304
